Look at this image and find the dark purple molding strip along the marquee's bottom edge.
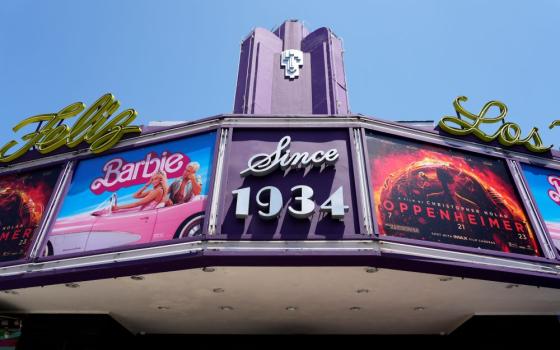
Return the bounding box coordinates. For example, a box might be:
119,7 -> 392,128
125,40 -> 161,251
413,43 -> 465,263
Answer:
0,250 -> 560,290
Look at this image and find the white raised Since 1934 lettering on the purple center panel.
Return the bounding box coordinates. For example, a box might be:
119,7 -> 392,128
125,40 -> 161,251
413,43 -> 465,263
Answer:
232,136 -> 349,220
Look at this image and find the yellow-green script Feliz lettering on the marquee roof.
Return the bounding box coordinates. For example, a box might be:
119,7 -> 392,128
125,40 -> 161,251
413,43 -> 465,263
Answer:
0,94 -> 141,163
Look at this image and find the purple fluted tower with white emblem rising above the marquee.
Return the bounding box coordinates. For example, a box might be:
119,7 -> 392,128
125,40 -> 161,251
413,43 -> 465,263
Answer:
233,20 -> 350,115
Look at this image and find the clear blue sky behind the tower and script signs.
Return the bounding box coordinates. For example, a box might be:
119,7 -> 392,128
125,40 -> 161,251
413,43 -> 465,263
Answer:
0,0 -> 560,148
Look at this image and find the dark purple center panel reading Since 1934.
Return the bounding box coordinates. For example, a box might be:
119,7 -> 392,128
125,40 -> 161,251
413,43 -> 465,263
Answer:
221,129 -> 359,239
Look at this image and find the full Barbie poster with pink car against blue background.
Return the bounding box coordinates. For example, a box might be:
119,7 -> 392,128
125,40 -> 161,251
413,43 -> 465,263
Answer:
44,132 -> 215,255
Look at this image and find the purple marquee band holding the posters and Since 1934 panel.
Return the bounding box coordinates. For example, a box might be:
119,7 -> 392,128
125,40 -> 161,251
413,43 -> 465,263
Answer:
0,108 -> 560,285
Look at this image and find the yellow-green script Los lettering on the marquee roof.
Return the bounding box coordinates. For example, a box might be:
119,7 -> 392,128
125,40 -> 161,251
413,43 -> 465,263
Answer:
438,96 -> 560,153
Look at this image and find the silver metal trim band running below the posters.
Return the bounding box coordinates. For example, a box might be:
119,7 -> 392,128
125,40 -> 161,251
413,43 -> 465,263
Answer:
0,240 -> 560,278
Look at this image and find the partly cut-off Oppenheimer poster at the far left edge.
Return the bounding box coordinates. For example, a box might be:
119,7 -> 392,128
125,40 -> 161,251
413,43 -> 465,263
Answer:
0,167 -> 60,261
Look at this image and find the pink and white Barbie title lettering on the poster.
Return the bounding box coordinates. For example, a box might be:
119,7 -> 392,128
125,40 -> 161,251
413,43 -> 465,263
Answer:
90,151 -> 190,194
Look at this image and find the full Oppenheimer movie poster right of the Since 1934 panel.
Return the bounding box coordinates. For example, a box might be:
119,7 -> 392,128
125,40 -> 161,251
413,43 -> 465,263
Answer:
367,133 -> 542,256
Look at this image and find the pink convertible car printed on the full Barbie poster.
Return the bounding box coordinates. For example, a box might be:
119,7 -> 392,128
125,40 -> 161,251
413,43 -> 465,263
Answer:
43,195 -> 206,256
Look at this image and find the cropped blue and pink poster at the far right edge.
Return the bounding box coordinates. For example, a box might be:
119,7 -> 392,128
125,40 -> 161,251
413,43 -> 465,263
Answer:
522,164 -> 560,250
